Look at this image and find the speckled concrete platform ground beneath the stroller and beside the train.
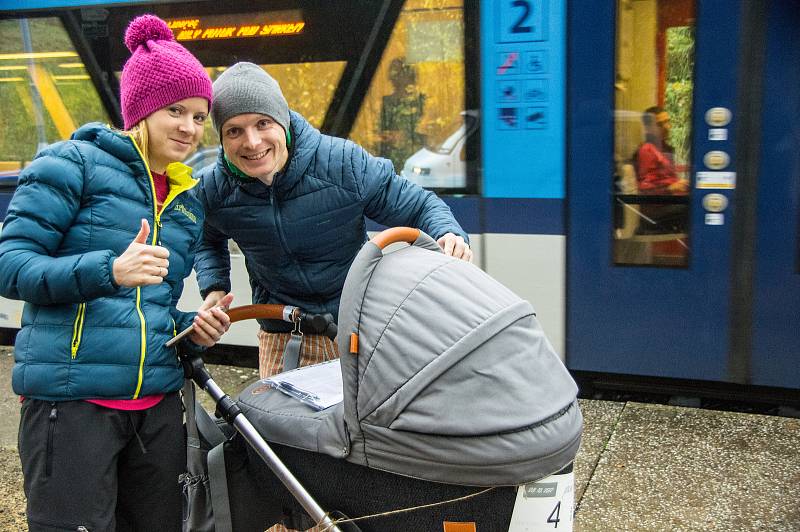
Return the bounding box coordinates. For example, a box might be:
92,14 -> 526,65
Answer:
0,348 -> 800,532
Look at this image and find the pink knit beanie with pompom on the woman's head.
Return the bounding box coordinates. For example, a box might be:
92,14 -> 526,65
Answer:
119,15 -> 212,129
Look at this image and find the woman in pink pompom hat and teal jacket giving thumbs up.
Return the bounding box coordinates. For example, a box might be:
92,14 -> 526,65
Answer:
0,15 -> 231,531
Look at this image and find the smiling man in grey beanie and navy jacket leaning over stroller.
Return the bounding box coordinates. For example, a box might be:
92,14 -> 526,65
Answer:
195,63 -> 472,384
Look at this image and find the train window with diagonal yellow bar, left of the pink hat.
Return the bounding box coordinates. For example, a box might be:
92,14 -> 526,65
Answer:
0,18 -> 109,172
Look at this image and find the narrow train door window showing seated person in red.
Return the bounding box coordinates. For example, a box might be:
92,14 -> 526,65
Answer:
611,0 -> 695,267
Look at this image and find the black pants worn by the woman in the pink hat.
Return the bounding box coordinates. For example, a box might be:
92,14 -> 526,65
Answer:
18,393 -> 186,532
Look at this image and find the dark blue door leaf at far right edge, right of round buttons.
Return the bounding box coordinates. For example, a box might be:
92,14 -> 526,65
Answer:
749,0 -> 800,388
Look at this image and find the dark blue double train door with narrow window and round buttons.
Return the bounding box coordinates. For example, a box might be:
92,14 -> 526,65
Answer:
567,0 -> 800,388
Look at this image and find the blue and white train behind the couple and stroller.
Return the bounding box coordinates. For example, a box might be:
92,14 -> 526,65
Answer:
0,0 -> 800,398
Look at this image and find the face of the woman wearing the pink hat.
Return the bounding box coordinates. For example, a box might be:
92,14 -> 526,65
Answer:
144,97 -> 208,174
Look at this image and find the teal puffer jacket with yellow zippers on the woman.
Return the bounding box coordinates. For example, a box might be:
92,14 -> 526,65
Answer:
0,124 -> 203,401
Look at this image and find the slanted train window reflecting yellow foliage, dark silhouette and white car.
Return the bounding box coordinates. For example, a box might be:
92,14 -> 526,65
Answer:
350,0 -> 468,192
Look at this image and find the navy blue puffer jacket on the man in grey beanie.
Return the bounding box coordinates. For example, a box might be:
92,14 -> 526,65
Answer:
195,112 -> 467,331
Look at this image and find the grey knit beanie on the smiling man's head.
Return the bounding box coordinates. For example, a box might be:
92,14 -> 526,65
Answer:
211,62 -> 289,134
